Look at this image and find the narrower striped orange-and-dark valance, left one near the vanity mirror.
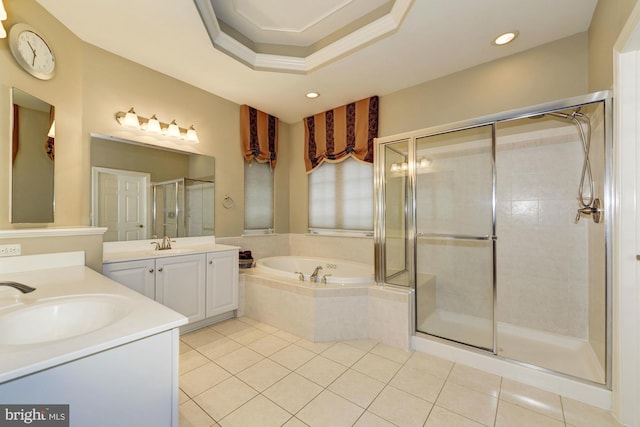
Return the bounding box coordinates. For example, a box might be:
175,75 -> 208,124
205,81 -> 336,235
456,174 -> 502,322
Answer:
240,105 -> 278,169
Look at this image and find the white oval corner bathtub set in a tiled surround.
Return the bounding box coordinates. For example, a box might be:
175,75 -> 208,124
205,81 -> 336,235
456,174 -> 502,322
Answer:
256,256 -> 374,284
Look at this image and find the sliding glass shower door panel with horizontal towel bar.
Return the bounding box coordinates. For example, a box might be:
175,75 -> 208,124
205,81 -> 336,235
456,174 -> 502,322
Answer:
414,125 -> 495,351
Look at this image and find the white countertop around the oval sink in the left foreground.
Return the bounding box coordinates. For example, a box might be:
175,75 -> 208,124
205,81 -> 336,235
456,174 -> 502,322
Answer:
0,253 -> 187,383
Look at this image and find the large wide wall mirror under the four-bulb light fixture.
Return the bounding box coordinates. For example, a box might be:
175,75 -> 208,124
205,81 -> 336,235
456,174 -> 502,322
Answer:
91,134 -> 215,242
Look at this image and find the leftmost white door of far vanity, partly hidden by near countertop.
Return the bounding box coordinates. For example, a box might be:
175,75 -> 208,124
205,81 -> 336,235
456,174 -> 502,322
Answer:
102,259 -> 155,299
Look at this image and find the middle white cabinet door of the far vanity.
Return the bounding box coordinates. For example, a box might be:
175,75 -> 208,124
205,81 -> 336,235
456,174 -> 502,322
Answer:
156,254 -> 205,322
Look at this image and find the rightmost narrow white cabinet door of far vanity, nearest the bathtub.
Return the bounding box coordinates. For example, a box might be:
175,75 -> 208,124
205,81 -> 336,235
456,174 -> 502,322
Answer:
207,251 -> 238,317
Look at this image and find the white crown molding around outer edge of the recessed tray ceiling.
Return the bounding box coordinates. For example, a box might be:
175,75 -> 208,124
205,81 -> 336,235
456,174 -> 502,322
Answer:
194,0 -> 414,74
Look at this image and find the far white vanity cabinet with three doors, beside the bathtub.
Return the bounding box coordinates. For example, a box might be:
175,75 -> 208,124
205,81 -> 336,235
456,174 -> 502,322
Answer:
102,249 -> 238,323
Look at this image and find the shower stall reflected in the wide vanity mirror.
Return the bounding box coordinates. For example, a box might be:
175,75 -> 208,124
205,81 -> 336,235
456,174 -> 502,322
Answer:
151,178 -> 214,237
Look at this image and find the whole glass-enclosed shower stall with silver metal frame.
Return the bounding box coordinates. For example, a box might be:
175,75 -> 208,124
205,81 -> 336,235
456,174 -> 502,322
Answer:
375,92 -> 612,388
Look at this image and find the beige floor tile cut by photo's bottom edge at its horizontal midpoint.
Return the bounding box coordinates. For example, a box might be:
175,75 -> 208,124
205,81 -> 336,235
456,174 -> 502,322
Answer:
296,390 -> 364,427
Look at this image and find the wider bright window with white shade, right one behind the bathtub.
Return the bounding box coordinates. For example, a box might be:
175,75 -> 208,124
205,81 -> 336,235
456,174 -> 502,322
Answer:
309,158 -> 373,232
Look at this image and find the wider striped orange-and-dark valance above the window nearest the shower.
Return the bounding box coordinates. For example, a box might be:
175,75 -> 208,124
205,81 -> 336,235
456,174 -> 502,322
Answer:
304,96 -> 378,173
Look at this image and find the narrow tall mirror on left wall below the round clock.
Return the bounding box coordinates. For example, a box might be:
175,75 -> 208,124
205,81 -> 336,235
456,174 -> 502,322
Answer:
11,88 -> 55,224
